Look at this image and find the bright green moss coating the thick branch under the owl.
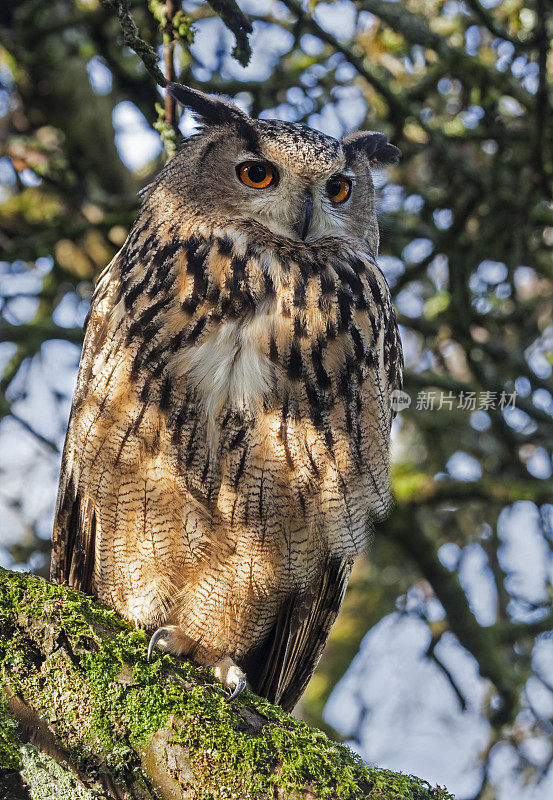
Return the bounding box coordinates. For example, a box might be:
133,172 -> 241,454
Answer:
0,570 -> 451,800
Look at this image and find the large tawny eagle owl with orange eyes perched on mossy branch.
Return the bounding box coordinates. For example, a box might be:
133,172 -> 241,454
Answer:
52,84 -> 402,709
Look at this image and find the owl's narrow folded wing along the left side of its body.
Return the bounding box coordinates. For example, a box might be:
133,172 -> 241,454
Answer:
50,265 -> 115,592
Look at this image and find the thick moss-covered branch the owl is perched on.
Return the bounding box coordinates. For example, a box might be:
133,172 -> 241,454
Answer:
0,570 -> 451,800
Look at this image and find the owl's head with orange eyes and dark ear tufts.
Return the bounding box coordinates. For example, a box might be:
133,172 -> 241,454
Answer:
151,83 -> 399,251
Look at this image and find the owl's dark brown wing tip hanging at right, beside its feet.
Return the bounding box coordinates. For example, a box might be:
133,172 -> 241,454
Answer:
244,559 -> 351,711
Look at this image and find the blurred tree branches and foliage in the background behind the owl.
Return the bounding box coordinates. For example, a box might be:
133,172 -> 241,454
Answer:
0,0 -> 553,800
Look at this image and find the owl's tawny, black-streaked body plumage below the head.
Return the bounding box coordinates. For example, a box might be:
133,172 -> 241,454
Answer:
53,214 -> 402,708
